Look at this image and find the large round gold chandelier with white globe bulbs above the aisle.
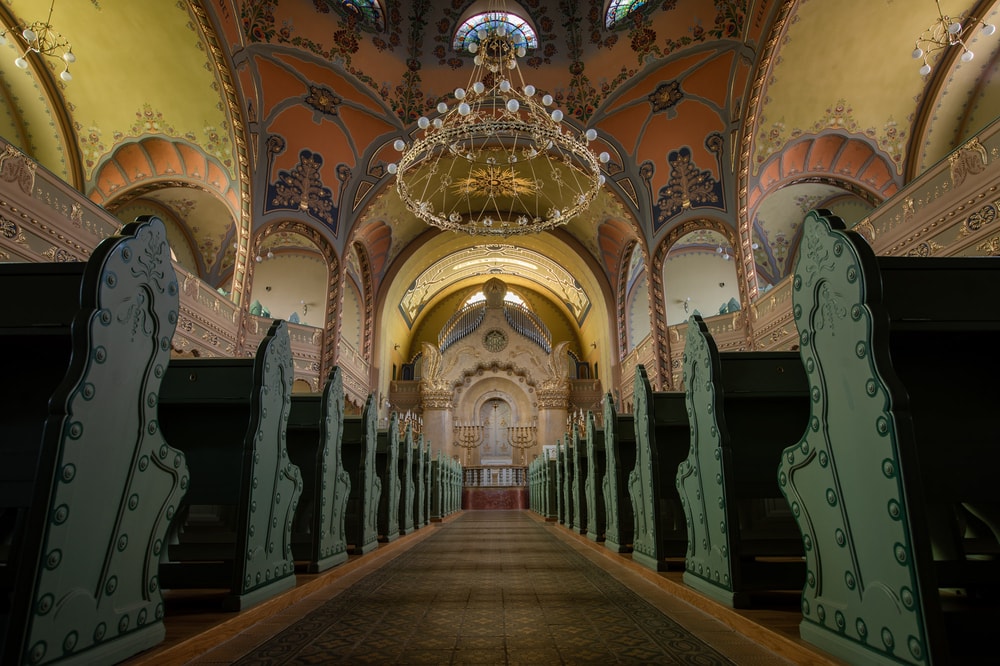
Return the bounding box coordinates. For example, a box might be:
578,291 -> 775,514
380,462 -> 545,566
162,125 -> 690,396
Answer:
388,9 -> 609,236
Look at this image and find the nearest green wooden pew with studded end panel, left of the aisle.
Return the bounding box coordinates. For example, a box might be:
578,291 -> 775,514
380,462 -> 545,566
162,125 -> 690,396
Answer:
0,217 -> 189,664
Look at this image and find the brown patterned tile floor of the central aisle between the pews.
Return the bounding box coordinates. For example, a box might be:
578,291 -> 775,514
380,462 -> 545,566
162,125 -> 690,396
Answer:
192,511 -> 812,664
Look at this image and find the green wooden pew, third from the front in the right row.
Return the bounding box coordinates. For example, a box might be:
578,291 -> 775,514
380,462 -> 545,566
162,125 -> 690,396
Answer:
628,365 -> 691,571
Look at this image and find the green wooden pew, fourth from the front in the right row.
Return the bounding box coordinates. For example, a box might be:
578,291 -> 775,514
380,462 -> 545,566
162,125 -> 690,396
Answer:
601,393 -> 635,553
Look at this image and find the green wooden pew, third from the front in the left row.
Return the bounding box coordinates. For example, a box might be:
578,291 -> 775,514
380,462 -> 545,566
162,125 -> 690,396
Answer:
287,366 -> 351,573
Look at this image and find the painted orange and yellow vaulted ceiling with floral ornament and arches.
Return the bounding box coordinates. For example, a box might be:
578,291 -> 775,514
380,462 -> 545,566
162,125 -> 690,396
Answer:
0,0 -> 1000,364
